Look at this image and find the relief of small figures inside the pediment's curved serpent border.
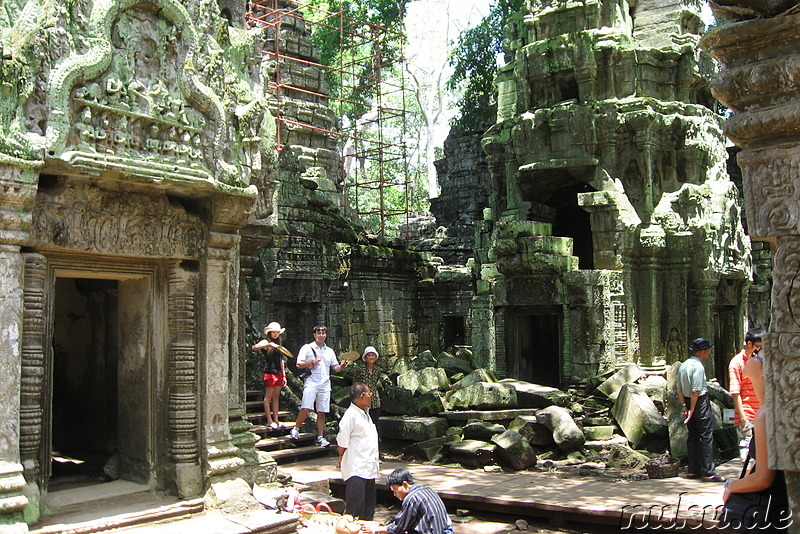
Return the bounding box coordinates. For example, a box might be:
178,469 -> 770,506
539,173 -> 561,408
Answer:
61,3 -> 210,180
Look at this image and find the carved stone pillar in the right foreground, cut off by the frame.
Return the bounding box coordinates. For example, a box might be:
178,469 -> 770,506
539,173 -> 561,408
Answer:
702,0 -> 800,532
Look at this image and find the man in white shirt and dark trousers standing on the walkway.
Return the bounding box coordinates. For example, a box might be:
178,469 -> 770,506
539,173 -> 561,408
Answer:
336,382 -> 380,521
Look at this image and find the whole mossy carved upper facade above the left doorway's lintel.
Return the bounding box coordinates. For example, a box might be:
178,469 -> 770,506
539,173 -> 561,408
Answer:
0,0 -> 274,195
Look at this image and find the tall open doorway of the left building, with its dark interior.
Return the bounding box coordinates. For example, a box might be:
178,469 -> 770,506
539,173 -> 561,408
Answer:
43,269 -> 160,491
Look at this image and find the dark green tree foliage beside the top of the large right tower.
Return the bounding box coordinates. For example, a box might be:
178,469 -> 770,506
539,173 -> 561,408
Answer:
447,0 -> 522,132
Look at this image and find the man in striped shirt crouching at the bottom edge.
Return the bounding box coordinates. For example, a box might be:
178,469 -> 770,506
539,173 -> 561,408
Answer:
372,467 -> 453,534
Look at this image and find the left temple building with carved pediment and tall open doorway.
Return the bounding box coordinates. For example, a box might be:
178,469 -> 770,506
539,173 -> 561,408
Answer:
0,0 -> 274,532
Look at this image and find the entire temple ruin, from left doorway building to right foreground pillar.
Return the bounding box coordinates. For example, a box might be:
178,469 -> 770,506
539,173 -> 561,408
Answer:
0,0 -> 800,532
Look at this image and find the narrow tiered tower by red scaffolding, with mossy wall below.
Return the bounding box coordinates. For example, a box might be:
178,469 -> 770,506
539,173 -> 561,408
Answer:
242,0 -> 438,364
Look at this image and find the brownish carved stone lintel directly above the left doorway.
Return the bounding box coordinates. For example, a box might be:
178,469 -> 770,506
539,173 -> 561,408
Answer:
31,186 -> 207,258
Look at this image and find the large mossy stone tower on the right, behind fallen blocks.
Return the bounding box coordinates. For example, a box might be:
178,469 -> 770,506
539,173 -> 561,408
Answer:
472,0 -> 766,386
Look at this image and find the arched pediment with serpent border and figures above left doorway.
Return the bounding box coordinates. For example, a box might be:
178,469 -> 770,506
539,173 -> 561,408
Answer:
46,0 -> 231,185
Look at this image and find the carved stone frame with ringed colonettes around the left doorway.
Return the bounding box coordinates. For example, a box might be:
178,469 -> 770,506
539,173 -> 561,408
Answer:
20,252 -> 169,495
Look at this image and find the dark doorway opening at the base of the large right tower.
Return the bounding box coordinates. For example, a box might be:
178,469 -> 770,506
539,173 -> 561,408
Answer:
506,311 -> 561,387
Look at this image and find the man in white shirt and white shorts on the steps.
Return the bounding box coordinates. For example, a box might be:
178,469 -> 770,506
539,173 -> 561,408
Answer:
290,326 -> 347,447
